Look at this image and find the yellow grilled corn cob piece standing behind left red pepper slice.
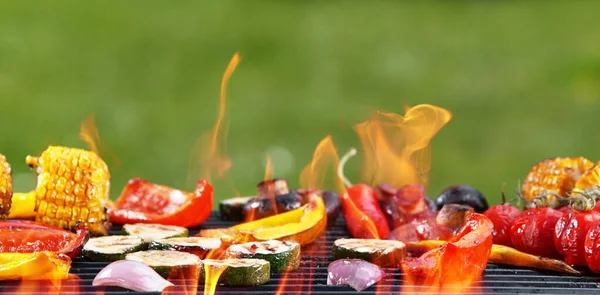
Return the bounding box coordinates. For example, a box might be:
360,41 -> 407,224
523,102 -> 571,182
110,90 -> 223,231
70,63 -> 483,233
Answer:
25,146 -> 110,235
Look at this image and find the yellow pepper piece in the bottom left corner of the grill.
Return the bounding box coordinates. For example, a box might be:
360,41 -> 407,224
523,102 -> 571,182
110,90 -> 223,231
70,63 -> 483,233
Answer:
0,251 -> 71,280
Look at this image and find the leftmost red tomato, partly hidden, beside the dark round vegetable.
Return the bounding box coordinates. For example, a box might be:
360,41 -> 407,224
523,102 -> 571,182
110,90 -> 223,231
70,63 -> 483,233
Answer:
483,204 -> 521,247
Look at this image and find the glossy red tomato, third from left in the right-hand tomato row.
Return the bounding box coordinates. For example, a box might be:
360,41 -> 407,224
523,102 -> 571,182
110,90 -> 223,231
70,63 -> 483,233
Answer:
554,211 -> 600,266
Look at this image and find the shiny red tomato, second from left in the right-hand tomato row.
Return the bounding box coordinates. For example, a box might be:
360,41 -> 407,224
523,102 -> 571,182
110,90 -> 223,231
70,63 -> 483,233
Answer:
510,208 -> 563,258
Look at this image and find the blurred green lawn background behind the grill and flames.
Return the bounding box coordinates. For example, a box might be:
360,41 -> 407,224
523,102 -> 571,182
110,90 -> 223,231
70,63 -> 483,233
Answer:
0,0 -> 600,207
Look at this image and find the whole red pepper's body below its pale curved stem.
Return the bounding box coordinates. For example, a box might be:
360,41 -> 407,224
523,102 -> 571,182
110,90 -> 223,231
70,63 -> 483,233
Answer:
341,184 -> 390,239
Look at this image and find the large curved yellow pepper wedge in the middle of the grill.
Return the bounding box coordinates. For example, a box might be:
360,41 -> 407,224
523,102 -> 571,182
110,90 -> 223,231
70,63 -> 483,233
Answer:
198,196 -> 327,246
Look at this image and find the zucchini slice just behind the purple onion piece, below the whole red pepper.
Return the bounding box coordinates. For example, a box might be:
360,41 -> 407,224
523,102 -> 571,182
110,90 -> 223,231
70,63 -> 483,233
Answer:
333,239 -> 406,267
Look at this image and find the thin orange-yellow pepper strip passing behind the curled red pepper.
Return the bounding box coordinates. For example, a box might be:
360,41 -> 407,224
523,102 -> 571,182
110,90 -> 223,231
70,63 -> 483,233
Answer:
406,240 -> 581,275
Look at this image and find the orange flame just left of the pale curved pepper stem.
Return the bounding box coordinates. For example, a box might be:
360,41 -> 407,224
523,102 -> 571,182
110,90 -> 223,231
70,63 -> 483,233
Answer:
300,135 -> 345,194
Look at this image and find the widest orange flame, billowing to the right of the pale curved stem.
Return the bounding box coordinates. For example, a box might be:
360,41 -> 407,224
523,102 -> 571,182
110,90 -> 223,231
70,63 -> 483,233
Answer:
354,104 -> 452,187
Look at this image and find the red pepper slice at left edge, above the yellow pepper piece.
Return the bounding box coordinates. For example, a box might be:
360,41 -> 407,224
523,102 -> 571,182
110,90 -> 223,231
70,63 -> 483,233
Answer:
0,220 -> 89,258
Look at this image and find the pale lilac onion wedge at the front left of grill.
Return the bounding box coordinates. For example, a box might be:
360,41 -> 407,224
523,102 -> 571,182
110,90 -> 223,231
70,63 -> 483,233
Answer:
92,260 -> 173,292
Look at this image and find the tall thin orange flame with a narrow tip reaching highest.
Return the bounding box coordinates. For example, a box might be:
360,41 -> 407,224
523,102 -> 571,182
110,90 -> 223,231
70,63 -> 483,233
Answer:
188,52 -> 241,183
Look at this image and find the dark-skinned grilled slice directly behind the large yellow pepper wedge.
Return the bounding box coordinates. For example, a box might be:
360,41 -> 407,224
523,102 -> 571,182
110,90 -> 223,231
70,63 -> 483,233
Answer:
244,192 -> 303,221
